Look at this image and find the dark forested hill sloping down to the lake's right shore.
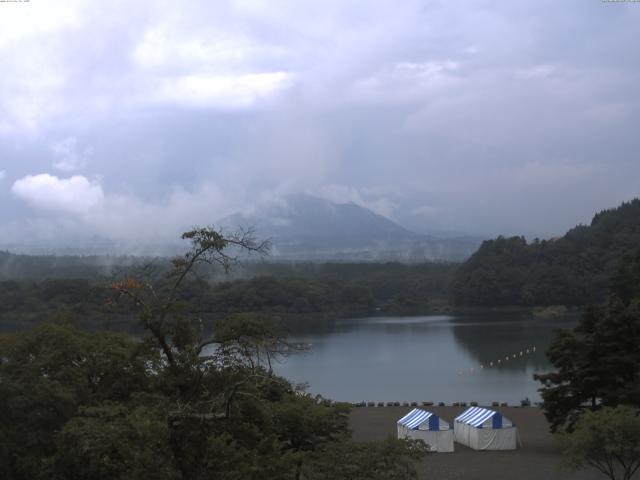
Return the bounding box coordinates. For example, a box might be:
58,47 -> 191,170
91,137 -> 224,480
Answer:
452,199 -> 640,306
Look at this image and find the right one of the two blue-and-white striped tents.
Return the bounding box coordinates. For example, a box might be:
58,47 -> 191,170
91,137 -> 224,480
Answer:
453,407 -> 518,450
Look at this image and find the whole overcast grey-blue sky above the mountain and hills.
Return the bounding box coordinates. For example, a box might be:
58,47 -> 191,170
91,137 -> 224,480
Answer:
0,0 -> 640,248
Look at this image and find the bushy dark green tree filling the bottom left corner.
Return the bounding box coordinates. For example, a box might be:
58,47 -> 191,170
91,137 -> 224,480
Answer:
0,320 -> 158,480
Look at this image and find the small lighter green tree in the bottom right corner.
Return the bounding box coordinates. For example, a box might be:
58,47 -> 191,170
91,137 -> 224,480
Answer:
560,407 -> 640,480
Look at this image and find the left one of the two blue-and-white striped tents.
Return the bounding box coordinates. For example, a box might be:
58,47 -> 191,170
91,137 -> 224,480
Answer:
398,408 -> 453,452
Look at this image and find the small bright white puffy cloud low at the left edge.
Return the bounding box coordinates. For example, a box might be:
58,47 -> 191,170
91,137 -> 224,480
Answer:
11,173 -> 104,214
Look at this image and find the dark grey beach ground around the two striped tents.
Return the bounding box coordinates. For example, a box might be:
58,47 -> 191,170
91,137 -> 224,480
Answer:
349,407 -> 604,480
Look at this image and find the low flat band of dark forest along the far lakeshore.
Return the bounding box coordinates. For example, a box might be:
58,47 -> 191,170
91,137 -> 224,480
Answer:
0,263 -> 455,331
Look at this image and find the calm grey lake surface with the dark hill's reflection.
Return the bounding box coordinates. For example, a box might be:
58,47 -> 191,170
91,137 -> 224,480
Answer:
276,314 -> 576,403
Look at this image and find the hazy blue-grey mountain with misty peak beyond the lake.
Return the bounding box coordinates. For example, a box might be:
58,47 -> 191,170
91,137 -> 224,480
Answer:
218,194 -> 480,262
